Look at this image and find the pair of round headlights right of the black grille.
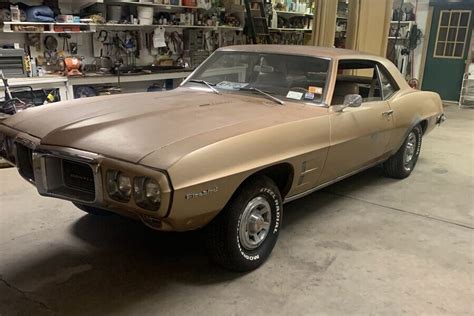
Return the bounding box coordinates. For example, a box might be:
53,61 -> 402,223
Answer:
106,170 -> 161,211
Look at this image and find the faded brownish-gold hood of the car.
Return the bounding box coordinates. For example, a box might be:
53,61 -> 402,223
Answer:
3,88 -> 326,168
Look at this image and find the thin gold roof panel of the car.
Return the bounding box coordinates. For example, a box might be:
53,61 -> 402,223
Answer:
219,44 -> 384,61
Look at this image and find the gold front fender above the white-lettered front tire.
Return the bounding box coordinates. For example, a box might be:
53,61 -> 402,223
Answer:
159,117 -> 329,230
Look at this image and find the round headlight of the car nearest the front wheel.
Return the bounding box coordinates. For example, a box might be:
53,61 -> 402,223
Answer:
133,177 -> 161,211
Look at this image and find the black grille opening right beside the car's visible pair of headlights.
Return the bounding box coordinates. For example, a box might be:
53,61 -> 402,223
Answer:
62,160 -> 95,193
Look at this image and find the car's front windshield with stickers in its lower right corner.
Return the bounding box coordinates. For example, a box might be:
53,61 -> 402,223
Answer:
187,51 -> 329,103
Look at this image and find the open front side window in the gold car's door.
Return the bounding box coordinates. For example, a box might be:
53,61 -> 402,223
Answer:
331,60 -> 382,105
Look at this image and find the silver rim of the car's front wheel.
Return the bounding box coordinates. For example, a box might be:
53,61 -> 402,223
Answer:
239,196 -> 272,250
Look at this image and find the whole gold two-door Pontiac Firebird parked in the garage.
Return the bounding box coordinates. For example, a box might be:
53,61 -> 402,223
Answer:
0,45 -> 445,271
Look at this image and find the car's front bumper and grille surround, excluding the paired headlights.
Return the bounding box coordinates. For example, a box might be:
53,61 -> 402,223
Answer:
0,125 -> 173,230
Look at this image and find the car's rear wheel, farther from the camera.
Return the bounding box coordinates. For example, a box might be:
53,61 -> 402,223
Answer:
383,125 -> 423,179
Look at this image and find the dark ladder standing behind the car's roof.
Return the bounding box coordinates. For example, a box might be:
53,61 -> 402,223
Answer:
244,0 -> 272,44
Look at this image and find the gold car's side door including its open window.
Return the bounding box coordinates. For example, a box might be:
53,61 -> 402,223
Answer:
321,61 -> 393,183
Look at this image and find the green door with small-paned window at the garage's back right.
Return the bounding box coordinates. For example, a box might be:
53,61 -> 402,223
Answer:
422,1 -> 473,101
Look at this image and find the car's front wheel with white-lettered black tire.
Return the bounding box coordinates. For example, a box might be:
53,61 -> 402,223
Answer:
206,177 -> 283,272
